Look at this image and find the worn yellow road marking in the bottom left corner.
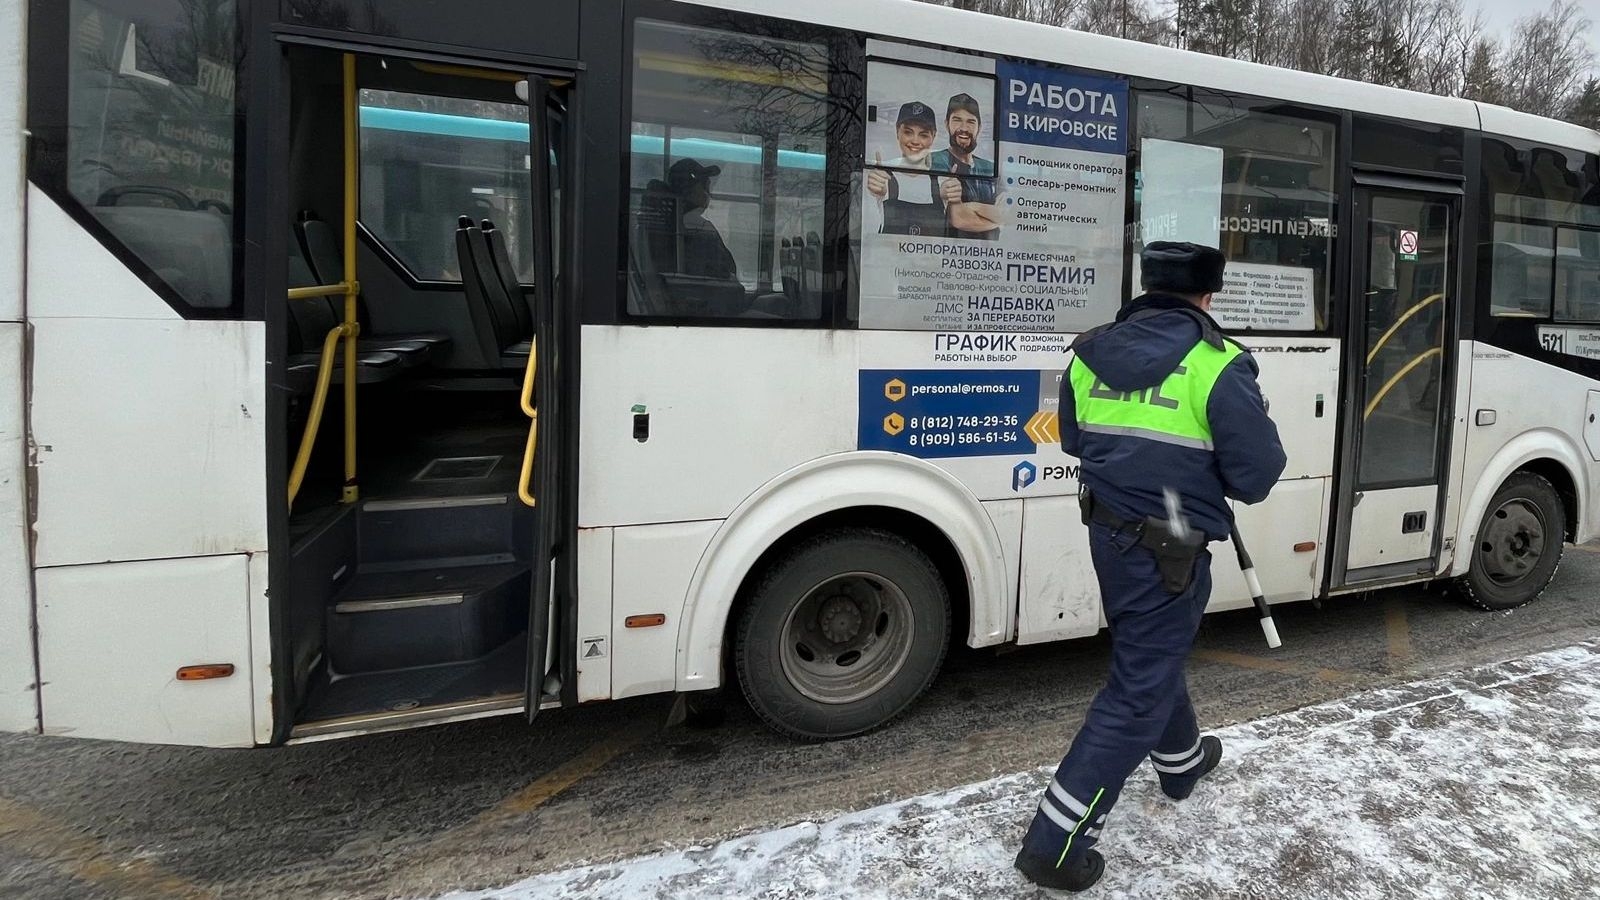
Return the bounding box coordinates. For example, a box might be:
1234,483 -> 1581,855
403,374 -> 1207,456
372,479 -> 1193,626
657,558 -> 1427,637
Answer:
0,798 -> 216,898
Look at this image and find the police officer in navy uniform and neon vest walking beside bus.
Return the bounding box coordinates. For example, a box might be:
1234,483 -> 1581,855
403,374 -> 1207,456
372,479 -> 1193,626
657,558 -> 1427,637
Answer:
1016,242 -> 1285,890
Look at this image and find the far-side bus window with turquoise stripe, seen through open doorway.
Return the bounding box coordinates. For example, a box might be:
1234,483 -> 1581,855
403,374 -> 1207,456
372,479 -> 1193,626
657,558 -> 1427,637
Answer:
360,88 -> 533,283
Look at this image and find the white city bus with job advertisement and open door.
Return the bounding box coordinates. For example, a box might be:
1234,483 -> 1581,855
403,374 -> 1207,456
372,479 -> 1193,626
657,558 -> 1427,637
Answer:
0,0 -> 1600,748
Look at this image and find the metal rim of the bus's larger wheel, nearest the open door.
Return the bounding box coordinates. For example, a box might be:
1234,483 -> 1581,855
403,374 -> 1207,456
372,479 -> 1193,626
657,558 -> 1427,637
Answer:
779,572 -> 915,703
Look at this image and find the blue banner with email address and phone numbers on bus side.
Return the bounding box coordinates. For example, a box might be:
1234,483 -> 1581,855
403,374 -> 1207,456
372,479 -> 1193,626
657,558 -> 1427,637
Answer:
856,368 -> 1040,460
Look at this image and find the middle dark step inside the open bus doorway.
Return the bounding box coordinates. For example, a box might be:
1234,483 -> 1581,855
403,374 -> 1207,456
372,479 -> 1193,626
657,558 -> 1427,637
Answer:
326,562 -> 530,676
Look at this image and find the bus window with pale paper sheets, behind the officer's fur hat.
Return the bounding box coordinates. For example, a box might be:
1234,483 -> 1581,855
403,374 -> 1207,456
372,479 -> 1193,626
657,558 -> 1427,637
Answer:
1133,88 -> 1339,331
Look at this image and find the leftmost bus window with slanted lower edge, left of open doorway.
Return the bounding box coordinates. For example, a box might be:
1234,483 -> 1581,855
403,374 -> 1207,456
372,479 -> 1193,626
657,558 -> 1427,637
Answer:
66,0 -> 243,311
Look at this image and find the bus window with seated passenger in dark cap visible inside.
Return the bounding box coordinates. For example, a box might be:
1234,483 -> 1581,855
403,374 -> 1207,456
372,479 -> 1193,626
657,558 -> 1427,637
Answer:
627,19 -> 829,320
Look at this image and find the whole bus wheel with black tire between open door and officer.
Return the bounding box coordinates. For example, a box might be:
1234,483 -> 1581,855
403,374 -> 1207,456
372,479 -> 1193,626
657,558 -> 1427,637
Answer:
734,528 -> 950,741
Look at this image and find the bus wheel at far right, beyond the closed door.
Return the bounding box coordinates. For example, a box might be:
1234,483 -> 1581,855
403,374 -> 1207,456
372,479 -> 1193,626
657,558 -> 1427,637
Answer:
1456,472 -> 1566,610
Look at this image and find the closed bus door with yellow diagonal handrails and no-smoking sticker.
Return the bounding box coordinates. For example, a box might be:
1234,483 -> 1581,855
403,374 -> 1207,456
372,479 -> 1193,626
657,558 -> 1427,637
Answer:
1339,179 -> 1461,585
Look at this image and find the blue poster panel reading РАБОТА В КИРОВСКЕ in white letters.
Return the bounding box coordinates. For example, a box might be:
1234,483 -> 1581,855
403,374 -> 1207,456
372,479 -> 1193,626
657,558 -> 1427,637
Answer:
995,62 -> 1128,155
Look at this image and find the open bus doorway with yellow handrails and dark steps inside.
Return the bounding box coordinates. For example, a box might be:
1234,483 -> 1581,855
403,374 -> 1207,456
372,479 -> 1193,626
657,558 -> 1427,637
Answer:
266,42 -> 578,741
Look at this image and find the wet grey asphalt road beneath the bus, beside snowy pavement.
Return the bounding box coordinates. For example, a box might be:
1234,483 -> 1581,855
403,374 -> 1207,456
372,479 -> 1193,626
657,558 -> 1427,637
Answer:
9,546 -> 1600,898
